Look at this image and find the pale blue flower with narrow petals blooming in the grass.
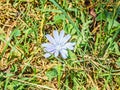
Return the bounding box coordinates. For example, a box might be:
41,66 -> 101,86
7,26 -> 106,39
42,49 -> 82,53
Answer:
42,30 -> 75,59
